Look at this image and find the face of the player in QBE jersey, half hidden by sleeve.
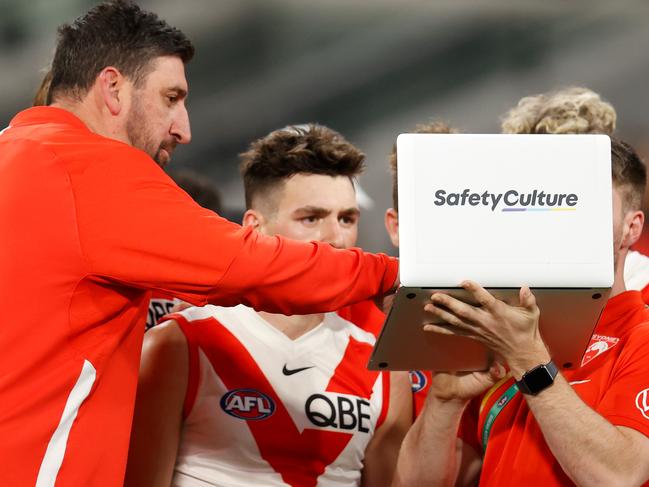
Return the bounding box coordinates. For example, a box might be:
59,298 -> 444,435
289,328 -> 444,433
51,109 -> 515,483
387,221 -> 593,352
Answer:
260,174 -> 360,248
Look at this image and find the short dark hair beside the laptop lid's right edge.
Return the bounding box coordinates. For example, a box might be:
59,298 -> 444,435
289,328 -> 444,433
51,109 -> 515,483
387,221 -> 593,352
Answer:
611,137 -> 647,211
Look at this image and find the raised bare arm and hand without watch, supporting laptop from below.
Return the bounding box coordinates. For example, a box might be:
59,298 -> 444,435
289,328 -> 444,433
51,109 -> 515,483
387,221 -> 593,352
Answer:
393,370 -> 505,487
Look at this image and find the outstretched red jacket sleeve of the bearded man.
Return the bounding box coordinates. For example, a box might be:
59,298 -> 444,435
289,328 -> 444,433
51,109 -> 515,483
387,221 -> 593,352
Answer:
69,145 -> 398,314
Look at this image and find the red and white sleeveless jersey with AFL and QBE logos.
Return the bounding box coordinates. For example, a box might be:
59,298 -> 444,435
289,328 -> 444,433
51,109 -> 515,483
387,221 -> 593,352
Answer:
169,305 -> 389,487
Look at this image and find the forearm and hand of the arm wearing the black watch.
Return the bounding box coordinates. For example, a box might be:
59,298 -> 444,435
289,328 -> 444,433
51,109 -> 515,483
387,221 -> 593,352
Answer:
426,282 -> 649,486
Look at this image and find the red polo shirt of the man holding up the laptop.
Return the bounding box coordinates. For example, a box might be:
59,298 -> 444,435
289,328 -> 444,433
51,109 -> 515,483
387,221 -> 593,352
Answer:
460,291 -> 649,487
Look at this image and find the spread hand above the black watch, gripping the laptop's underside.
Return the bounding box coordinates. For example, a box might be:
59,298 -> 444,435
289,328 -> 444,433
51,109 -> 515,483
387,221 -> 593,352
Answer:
424,281 -> 550,379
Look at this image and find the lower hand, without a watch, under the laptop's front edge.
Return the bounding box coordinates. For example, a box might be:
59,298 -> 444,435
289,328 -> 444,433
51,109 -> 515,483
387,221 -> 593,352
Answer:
429,362 -> 506,402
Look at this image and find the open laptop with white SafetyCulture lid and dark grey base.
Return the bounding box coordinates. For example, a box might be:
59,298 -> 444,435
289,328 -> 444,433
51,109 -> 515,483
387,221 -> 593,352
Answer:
369,134 -> 613,370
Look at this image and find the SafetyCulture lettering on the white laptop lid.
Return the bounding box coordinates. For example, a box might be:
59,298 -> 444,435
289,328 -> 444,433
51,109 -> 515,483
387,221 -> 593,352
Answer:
433,188 -> 579,211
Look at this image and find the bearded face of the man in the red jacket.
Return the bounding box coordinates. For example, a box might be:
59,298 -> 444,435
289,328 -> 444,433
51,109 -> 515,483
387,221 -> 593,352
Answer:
126,56 -> 191,167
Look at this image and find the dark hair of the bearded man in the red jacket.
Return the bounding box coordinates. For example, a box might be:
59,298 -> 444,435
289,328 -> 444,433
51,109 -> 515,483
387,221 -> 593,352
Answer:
49,0 -> 194,100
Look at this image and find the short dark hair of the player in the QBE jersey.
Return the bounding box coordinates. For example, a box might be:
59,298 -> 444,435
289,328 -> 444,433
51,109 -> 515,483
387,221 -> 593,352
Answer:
240,124 -> 365,208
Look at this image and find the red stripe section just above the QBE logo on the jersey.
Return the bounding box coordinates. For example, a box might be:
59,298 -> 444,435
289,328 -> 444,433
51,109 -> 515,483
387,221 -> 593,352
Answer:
326,336 -> 379,399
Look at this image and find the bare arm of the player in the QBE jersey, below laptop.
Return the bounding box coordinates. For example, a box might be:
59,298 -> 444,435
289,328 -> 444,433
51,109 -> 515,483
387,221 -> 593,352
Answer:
362,372 -> 412,487
